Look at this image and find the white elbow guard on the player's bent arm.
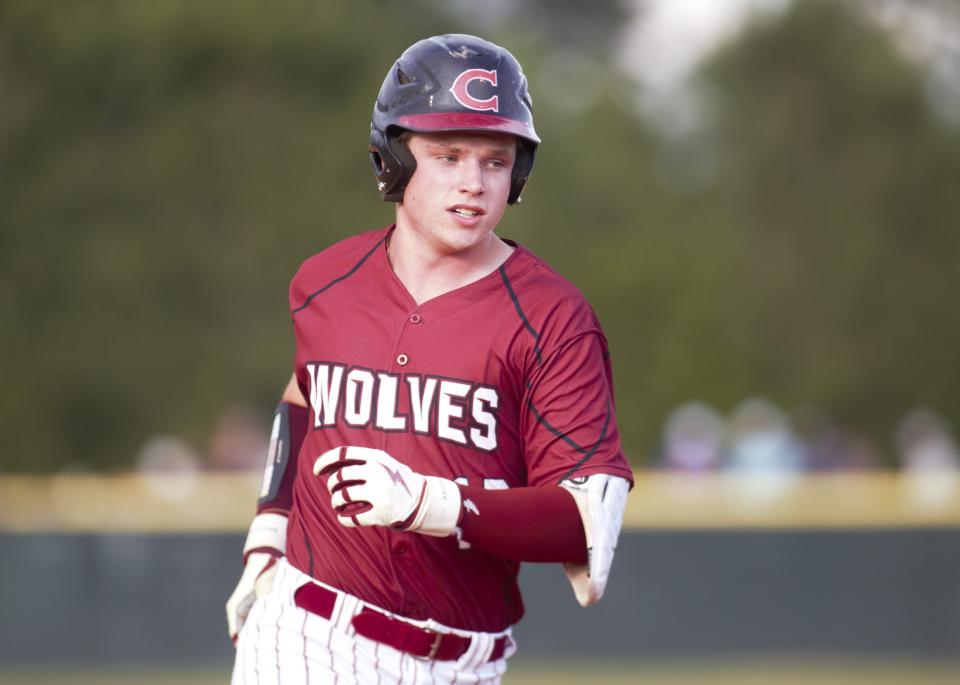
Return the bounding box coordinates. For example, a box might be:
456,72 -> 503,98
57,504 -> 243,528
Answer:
560,473 -> 630,606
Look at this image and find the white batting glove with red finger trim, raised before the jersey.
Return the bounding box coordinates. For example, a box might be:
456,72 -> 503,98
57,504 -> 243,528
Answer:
313,446 -> 460,537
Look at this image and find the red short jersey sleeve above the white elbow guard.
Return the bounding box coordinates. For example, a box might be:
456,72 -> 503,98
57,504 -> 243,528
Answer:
522,328 -> 633,485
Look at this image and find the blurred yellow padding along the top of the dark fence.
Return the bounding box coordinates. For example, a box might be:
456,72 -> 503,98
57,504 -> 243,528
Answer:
0,471 -> 960,533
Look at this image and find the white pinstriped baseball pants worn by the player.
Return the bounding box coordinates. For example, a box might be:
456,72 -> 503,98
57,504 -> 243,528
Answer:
231,559 -> 516,685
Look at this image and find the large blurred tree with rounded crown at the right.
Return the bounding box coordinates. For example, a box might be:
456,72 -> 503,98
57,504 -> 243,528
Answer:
692,3 -> 960,438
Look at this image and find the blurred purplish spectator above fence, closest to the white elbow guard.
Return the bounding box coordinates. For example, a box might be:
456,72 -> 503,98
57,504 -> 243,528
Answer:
663,401 -> 725,473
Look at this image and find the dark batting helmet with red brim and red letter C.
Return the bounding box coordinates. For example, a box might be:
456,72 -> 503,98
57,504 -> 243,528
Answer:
370,34 -> 540,204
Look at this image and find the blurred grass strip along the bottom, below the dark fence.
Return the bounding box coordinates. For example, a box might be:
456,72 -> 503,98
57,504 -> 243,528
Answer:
0,659 -> 960,685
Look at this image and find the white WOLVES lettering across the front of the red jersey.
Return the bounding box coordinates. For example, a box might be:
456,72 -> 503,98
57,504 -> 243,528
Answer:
306,362 -> 500,452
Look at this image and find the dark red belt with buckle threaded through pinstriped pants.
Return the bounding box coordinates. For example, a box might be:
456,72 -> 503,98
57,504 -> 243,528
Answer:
293,583 -> 509,661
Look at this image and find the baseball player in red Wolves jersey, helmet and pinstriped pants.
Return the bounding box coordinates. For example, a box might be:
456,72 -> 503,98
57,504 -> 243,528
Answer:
226,35 -> 631,685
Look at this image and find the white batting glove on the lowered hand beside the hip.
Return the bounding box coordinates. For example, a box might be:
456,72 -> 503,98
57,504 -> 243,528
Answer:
226,514 -> 287,644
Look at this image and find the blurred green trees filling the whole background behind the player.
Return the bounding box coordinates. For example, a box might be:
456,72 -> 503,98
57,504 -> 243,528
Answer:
0,0 -> 960,470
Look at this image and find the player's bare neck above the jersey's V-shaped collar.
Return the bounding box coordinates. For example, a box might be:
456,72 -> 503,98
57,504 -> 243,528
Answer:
387,225 -> 514,304
